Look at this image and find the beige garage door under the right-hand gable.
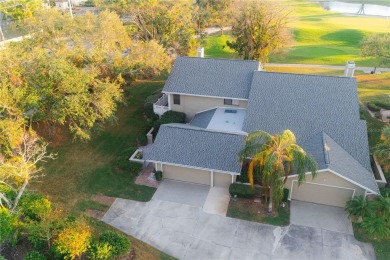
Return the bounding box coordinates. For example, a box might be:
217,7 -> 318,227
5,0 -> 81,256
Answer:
291,181 -> 354,207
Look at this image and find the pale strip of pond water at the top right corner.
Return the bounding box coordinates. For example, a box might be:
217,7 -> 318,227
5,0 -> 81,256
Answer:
320,1 -> 390,17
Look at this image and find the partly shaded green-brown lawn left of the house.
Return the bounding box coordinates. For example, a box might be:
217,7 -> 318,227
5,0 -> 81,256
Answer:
30,81 -> 169,259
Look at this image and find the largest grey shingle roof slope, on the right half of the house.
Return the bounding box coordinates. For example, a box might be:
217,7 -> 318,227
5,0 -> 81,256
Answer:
243,72 -> 371,171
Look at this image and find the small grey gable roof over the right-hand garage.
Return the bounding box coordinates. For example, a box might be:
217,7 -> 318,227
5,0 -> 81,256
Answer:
301,132 -> 378,192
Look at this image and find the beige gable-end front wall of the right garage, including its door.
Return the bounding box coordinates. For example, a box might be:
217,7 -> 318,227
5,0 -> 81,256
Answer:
285,172 -> 365,207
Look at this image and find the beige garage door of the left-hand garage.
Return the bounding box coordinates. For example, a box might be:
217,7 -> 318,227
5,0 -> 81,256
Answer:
163,165 -> 210,185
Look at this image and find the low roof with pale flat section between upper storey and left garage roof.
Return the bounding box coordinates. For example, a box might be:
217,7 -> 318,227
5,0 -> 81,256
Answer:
190,108 -> 246,133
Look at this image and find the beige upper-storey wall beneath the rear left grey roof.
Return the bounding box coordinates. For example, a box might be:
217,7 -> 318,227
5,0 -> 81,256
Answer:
168,94 -> 248,122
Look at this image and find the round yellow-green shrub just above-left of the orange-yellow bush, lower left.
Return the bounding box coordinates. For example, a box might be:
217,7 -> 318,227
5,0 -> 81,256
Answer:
19,193 -> 51,221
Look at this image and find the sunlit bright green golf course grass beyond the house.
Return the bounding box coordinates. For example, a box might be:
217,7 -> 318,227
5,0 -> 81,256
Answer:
200,0 -> 390,66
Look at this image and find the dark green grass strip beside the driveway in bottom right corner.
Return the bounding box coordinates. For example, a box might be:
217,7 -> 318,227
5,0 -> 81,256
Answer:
353,223 -> 390,260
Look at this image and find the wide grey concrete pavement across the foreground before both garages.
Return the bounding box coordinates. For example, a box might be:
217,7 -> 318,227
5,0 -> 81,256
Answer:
103,199 -> 375,260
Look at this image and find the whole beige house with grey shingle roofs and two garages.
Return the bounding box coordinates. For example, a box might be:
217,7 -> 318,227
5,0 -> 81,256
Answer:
133,57 -> 378,207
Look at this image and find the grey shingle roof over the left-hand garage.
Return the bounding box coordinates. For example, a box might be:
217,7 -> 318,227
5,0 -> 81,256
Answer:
143,124 -> 245,174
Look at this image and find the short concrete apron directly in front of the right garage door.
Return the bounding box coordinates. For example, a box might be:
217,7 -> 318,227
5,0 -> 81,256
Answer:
290,200 -> 353,235
